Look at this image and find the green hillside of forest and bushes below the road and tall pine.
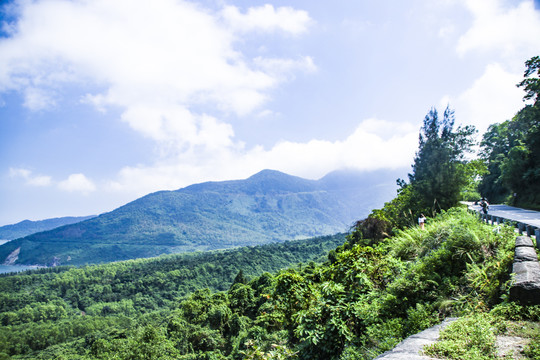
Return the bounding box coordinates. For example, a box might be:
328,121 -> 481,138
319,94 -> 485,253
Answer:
0,209 -> 540,360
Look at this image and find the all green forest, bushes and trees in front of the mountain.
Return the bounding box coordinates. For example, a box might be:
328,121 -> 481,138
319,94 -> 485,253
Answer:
0,57 -> 540,360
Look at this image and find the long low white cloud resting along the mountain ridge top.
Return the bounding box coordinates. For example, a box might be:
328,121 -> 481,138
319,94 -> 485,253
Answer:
108,119 -> 418,195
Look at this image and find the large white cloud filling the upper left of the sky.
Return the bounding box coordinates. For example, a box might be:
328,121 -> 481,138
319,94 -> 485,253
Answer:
0,0 -> 315,146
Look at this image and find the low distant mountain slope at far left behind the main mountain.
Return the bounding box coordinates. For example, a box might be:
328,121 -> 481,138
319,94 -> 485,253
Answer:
0,215 -> 95,240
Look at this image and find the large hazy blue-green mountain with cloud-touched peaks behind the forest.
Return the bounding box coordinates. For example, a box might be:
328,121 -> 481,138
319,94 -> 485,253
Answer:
0,170 -> 402,265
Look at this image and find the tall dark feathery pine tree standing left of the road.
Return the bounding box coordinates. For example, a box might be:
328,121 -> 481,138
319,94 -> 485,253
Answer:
370,107 -> 476,228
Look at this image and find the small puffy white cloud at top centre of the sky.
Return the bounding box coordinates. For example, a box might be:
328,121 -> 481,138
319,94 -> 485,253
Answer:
223,4 -> 312,35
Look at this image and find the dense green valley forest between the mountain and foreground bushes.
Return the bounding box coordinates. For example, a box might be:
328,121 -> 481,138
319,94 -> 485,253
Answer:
0,234 -> 345,359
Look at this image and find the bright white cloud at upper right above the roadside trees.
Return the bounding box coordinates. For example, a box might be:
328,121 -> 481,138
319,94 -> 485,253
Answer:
448,0 -> 540,135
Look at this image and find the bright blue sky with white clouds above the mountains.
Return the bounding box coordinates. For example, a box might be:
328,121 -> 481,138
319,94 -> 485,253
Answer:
0,0 -> 540,225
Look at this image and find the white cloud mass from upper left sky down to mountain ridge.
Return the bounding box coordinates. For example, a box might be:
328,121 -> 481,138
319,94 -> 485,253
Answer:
0,0 -> 417,194
